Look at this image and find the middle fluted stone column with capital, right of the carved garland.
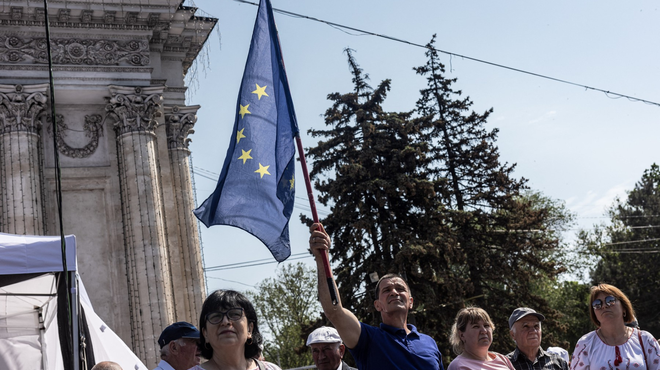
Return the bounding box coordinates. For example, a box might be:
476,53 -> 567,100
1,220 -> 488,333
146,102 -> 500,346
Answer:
106,85 -> 174,367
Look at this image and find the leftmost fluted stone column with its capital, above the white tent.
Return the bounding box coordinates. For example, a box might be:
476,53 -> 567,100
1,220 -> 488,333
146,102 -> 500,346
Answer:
0,84 -> 48,235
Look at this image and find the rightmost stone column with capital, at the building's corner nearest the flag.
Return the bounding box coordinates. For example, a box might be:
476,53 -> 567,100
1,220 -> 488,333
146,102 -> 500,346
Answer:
164,105 -> 206,323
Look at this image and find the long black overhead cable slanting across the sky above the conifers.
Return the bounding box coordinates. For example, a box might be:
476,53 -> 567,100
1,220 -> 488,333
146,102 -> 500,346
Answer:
229,0 -> 660,107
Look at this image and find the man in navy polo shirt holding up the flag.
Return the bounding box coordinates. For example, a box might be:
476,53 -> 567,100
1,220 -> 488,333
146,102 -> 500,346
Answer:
309,223 -> 444,370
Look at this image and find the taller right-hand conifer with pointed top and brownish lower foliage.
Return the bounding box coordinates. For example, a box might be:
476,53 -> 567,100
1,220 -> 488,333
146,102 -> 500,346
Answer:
415,36 -> 570,351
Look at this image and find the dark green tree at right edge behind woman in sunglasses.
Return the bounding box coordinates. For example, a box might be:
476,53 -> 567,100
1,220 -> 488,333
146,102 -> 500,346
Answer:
580,163 -> 660,337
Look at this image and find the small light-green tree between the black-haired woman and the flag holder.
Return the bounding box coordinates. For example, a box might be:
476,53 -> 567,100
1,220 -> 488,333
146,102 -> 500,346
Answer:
246,262 -> 321,369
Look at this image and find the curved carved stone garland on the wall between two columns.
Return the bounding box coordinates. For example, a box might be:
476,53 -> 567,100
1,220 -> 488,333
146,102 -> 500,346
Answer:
46,114 -> 103,158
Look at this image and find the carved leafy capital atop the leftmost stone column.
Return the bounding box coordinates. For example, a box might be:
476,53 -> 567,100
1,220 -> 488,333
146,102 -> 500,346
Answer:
0,84 -> 48,134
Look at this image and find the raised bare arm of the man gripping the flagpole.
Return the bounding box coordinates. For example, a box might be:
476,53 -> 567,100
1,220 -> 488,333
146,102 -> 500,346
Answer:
309,224 -> 361,348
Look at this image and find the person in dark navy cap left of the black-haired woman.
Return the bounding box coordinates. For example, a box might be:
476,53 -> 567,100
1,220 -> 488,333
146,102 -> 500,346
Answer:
154,321 -> 201,370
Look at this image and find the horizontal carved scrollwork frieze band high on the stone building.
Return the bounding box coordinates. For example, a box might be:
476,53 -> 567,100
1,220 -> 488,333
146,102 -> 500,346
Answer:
0,35 -> 149,66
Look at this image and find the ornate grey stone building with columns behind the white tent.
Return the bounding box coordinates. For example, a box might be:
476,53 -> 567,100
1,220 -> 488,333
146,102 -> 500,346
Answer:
0,0 -> 217,367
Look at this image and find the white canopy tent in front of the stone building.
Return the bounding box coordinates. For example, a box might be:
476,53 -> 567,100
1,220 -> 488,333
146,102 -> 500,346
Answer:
0,233 -> 148,370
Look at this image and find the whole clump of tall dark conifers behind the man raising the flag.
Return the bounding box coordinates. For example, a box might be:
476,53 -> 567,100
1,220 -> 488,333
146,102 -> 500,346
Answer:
303,40 -> 572,364
